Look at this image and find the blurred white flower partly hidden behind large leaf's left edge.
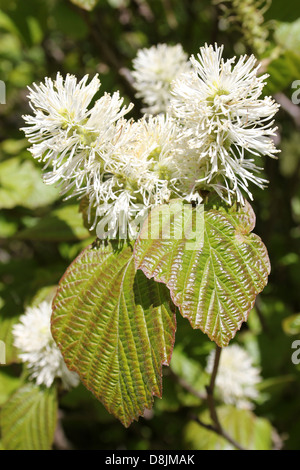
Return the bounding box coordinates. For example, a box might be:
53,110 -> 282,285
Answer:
13,301 -> 79,389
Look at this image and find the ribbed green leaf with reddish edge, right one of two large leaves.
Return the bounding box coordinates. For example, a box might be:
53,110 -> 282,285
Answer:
134,199 -> 270,347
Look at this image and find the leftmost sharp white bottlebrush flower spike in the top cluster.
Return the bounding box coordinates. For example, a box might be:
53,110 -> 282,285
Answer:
23,73 -> 132,193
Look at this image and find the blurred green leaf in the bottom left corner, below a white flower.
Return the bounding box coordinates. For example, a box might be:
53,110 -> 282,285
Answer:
1,383 -> 57,450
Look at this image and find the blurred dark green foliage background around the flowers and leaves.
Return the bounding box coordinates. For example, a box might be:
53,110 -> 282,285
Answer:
0,0 -> 300,450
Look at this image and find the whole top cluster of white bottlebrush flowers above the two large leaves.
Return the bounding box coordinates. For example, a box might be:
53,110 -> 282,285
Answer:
23,44 -> 278,238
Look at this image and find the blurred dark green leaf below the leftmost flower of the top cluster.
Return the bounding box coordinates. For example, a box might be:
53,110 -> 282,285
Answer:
17,204 -> 90,242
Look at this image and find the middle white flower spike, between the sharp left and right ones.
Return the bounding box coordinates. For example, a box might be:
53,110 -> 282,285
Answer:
94,115 -> 179,238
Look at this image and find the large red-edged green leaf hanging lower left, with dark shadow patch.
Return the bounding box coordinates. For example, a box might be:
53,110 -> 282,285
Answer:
52,244 -> 176,427
